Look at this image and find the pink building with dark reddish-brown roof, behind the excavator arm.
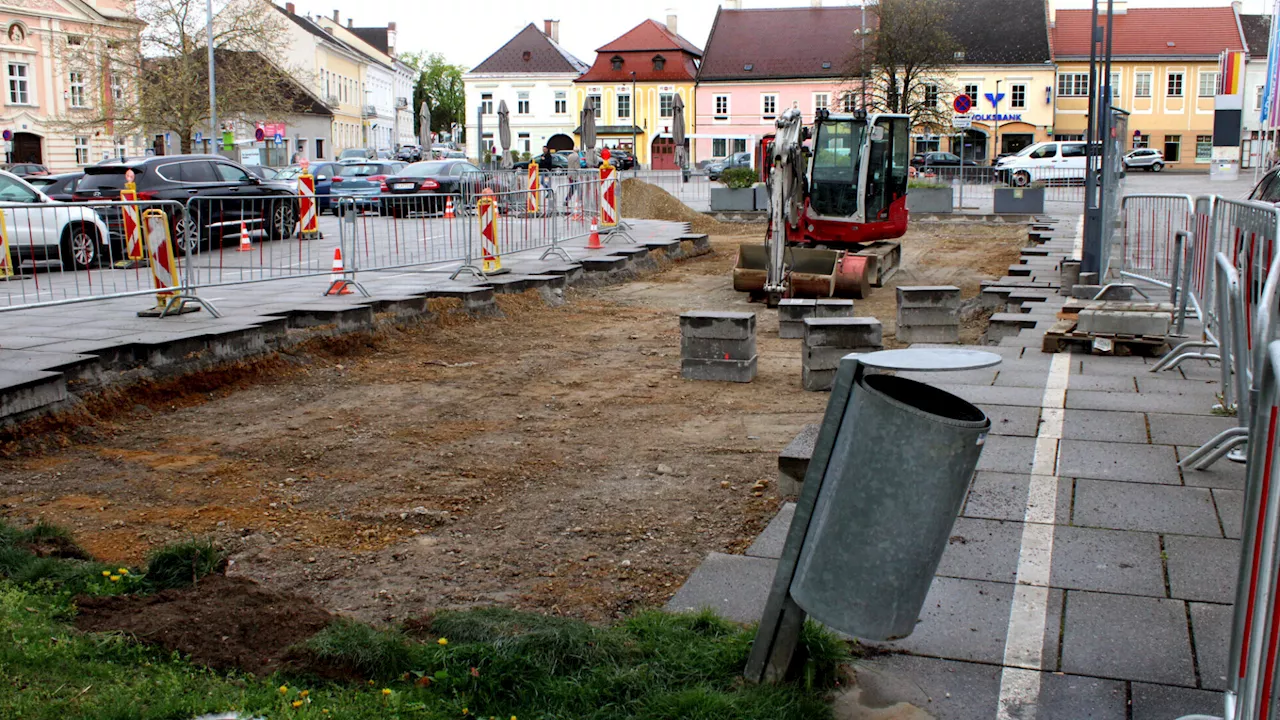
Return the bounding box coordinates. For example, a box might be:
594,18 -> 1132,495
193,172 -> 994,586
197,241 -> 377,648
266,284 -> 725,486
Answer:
692,6 -> 874,160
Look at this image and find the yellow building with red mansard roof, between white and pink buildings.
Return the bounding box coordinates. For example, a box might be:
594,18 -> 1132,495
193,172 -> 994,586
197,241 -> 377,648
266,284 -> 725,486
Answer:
573,15 -> 703,169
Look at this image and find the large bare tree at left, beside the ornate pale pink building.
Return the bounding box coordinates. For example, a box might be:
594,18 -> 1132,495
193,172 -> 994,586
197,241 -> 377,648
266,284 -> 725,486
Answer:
59,0 -> 300,152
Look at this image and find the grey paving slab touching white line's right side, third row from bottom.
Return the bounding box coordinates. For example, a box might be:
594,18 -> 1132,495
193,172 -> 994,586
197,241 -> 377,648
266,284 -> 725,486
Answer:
1050,525 -> 1165,597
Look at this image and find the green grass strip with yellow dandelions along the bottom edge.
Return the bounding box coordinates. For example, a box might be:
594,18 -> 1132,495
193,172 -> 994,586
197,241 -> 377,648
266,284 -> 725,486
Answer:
0,523 -> 847,720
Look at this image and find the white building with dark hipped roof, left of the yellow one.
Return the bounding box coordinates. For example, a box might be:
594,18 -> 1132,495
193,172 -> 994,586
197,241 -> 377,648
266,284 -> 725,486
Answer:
462,20 -> 588,159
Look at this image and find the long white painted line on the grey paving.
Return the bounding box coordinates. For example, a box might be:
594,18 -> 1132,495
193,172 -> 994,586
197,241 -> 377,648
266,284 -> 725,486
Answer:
996,326 -> 1079,720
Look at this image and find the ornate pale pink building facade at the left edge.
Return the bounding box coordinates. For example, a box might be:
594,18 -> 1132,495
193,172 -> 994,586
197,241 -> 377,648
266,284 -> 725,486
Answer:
0,0 -> 145,172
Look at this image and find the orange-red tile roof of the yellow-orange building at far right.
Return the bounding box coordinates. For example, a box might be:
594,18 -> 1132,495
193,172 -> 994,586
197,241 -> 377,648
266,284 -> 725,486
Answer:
1053,6 -> 1244,58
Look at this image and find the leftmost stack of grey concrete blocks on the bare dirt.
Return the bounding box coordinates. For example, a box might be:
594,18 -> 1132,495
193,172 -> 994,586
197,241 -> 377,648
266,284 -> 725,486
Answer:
680,311 -> 756,383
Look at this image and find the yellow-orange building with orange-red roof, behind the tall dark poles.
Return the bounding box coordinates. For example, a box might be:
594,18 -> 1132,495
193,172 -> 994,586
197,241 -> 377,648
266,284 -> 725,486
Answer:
1052,0 -> 1244,170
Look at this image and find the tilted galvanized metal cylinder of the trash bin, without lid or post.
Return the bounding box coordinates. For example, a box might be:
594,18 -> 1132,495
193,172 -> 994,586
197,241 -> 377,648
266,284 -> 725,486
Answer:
791,374 -> 991,641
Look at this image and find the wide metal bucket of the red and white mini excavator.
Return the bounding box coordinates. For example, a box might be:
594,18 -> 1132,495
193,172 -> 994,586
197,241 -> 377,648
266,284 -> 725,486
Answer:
733,245 -> 876,299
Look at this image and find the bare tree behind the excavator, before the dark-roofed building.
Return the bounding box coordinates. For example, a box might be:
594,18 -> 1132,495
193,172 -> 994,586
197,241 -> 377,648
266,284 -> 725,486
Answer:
846,0 -> 960,132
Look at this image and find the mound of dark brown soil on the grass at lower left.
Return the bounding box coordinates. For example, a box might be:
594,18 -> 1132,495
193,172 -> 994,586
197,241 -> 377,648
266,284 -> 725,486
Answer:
76,575 -> 333,675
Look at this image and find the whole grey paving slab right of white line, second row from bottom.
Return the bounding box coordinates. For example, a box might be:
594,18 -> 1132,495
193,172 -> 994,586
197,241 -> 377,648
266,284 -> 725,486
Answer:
1062,591 -> 1196,687
